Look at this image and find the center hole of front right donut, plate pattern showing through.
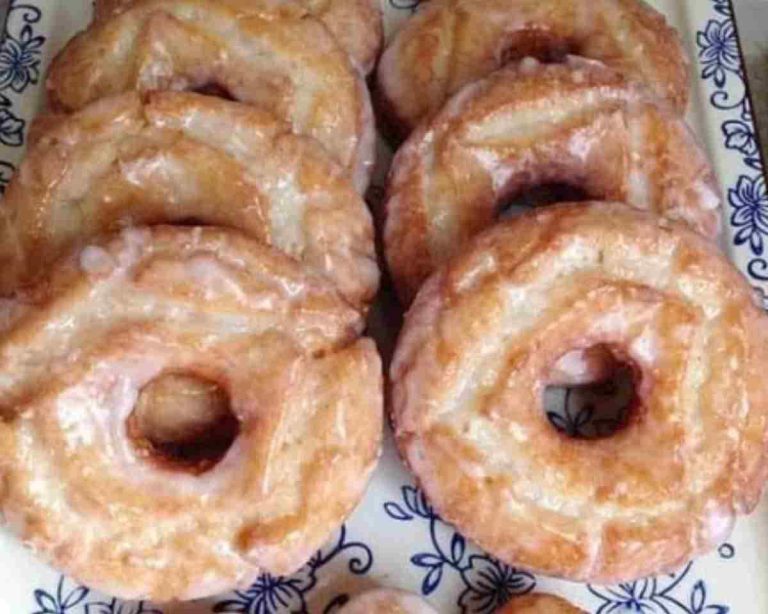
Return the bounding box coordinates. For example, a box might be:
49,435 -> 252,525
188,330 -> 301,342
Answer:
543,345 -> 638,439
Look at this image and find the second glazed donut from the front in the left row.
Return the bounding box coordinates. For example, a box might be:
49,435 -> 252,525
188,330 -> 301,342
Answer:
0,92 -> 378,309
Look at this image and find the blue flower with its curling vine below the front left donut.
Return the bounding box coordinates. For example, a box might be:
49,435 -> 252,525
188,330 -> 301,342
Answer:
213,527 -> 373,614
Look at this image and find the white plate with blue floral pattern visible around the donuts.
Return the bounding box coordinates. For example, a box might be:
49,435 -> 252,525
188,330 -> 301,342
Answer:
0,0 -> 768,614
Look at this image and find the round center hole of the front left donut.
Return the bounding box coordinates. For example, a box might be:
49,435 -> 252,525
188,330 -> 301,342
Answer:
127,373 -> 240,474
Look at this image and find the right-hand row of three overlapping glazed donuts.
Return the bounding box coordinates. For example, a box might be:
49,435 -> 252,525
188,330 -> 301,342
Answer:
377,0 -> 768,612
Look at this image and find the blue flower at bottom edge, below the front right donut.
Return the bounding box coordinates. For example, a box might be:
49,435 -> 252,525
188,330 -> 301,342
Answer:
459,555 -> 536,614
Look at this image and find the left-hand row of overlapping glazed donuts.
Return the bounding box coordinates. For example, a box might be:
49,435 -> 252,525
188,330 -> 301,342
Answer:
0,0 -> 383,601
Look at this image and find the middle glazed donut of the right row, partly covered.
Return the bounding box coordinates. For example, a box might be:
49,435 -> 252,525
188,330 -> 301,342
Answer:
384,58 -> 720,302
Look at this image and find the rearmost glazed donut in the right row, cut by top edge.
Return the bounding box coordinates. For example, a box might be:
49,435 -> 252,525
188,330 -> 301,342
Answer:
378,0 -> 690,135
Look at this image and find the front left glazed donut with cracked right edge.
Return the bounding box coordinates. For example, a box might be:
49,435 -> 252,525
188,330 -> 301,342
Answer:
0,226 -> 382,601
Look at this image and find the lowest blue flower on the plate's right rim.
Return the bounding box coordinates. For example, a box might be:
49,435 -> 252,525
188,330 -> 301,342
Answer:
728,175 -> 768,256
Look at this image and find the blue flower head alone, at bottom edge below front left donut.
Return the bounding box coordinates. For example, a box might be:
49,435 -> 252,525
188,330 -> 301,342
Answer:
213,566 -> 317,614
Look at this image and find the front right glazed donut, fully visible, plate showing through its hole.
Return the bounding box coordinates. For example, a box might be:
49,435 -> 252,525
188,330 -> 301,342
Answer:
391,203 -> 768,584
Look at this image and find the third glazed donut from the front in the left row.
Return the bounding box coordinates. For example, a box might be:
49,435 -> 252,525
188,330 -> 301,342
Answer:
47,0 -> 375,192
